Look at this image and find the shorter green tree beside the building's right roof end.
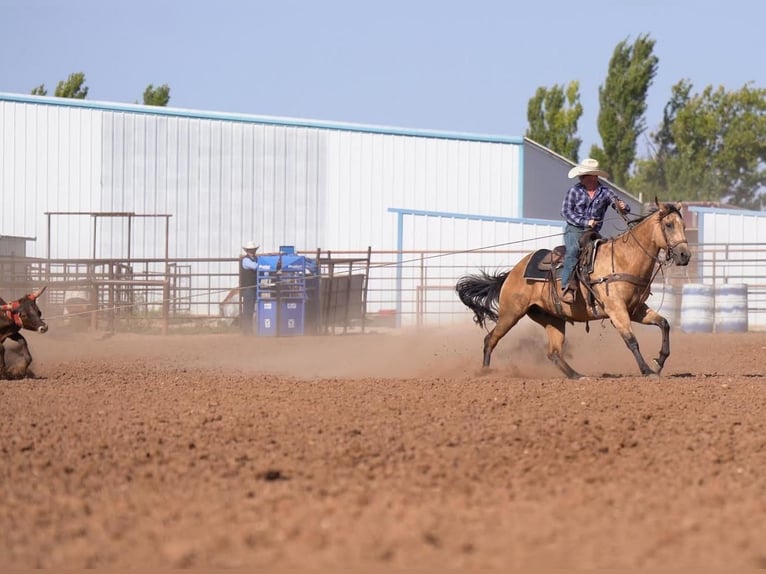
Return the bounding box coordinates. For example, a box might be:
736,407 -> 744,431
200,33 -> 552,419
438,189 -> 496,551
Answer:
526,81 -> 583,162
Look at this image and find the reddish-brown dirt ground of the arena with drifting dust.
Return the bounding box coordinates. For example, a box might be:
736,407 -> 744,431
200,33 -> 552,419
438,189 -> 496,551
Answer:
0,323 -> 766,570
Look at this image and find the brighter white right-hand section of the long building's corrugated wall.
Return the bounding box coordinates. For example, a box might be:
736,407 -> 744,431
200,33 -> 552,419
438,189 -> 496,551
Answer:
324,132 -> 520,249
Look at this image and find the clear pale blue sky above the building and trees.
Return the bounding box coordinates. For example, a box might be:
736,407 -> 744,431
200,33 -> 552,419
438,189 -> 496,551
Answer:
0,0 -> 766,157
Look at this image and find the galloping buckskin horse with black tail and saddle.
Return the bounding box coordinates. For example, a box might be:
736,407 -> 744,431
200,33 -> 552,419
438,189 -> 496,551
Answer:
455,198 -> 691,379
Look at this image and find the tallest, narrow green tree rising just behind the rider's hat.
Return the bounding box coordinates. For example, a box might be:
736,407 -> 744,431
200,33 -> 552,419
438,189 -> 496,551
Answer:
590,35 -> 658,185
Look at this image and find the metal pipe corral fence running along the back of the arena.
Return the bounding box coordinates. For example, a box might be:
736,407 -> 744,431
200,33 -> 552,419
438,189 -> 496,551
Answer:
0,244 -> 766,334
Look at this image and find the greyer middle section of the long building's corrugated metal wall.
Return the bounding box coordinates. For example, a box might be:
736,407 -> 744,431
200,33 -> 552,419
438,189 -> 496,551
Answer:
103,112 -> 325,257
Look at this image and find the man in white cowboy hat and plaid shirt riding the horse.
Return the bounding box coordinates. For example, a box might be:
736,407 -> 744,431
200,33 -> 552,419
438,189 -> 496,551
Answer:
561,158 -> 630,303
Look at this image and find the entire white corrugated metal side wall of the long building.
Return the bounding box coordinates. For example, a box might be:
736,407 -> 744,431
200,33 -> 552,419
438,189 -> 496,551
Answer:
0,95 -> 522,258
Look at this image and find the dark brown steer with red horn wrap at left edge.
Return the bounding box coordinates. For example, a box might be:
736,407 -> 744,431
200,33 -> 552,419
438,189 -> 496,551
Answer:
0,287 -> 48,379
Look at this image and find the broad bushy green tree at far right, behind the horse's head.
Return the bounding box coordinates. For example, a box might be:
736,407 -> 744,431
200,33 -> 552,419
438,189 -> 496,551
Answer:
633,81 -> 766,209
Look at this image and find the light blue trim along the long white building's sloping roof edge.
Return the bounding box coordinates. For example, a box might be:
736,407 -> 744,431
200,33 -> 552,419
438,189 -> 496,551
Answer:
0,92 -> 524,146
